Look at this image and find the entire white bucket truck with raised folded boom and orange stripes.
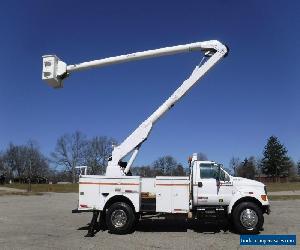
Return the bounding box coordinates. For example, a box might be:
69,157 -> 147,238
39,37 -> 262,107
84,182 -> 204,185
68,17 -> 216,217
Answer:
42,40 -> 270,236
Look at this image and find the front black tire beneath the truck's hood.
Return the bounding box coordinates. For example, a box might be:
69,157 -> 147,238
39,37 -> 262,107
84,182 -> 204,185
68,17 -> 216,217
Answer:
232,202 -> 264,234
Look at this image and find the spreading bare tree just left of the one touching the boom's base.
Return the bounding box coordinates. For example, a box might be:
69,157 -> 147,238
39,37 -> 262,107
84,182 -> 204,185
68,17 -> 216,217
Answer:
51,131 -> 87,183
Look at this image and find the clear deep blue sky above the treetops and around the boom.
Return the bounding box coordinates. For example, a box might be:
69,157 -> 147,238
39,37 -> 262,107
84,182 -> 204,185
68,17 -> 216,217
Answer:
0,0 -> 300,168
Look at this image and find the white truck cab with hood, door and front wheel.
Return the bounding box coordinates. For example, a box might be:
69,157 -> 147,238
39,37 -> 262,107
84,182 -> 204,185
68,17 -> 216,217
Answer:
190,154 -> 270,234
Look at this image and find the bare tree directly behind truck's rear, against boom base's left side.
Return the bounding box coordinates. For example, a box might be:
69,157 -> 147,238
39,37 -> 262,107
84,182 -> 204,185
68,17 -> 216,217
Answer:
85,136 -> 117,174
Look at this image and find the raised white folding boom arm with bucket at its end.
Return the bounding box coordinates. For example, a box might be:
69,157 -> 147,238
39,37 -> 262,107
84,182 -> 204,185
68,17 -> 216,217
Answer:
42,40 -> 228,176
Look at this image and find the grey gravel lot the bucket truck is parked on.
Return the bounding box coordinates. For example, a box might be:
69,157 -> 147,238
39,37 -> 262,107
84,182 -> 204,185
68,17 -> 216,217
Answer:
0,193 -> 300,249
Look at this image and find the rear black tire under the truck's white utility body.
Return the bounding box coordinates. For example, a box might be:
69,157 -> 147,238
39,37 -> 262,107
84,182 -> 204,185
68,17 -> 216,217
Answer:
105,202 -> 135,234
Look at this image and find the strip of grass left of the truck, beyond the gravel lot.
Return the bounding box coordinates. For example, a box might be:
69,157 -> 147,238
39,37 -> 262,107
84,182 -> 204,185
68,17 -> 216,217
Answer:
5,183 -> 78,193
